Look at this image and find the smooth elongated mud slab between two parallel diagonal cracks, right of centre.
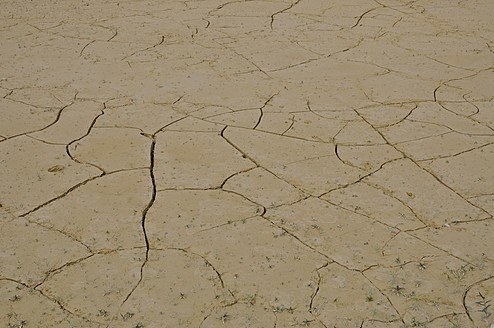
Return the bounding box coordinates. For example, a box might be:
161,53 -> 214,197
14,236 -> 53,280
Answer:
265,198 -> 396,269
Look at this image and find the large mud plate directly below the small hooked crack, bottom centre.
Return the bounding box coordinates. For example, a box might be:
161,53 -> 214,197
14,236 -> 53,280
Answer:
189,217 -> 327,308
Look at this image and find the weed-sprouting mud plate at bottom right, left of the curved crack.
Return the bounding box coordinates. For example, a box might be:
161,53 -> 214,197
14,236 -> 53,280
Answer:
364,256 -> 488,324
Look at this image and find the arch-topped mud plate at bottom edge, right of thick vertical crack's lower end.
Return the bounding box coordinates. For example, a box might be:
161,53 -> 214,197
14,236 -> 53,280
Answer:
116,250 -> 233,328
